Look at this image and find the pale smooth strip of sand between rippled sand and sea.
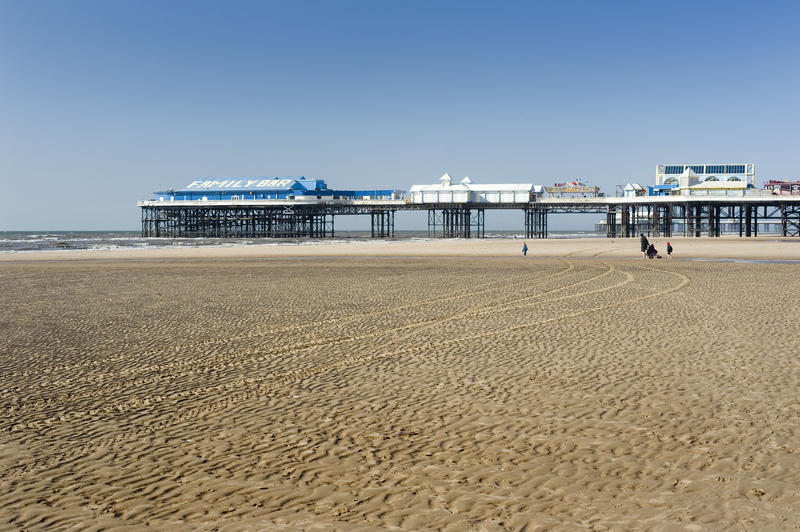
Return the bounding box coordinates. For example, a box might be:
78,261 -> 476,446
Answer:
0,236 -> 800,263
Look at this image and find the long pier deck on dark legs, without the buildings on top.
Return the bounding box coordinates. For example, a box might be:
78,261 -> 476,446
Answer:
137,194 -> 800,238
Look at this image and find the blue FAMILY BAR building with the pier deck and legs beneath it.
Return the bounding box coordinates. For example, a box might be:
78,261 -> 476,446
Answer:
138,177 -> 402,238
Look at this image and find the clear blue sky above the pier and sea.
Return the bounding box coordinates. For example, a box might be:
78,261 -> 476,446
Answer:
0,0 -> 800,230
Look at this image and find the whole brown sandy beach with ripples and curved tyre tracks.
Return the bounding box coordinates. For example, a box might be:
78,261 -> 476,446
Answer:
0,237 -> 800,530
